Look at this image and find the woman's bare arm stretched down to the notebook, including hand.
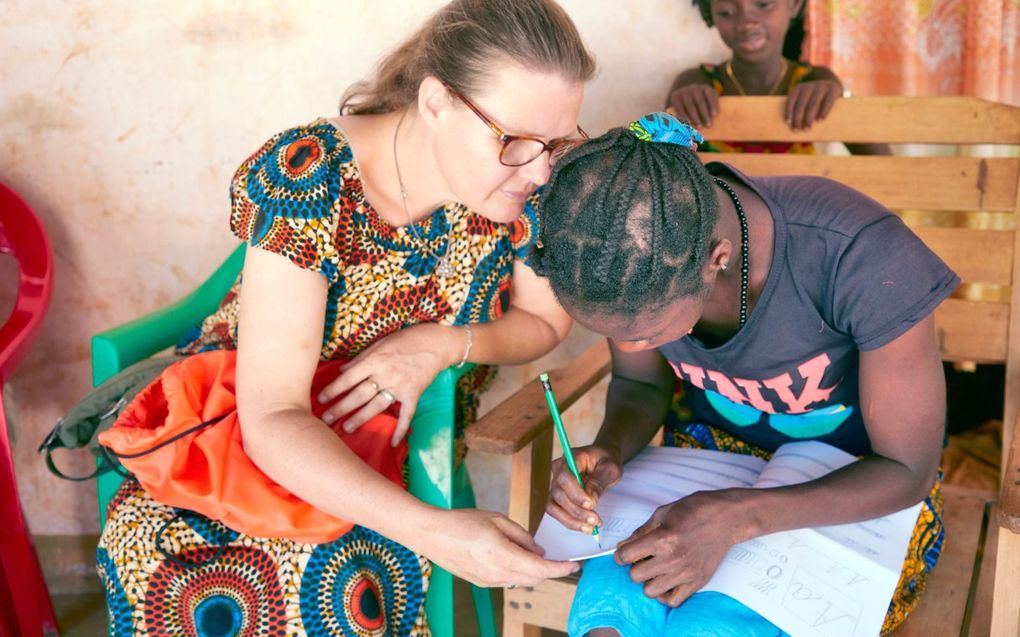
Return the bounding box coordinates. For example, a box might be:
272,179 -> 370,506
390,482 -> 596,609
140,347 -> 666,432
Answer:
237,249 -> 573,585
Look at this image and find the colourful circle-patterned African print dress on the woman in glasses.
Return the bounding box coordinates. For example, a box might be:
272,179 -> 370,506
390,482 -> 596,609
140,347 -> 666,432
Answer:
97,120 -> 537,637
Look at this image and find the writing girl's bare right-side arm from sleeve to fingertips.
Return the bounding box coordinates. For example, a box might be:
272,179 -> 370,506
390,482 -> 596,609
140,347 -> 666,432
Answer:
616,315 -> 946,606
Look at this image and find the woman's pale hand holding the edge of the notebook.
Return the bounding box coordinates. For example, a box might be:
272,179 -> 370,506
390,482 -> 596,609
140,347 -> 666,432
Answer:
412,509 -> 579,587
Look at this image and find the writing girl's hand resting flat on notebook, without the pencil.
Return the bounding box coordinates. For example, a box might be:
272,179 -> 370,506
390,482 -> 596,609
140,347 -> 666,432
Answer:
615,489 -> 740,608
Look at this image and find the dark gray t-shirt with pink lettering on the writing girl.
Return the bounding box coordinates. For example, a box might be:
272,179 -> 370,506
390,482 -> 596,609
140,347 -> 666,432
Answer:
660,163 -> 960,455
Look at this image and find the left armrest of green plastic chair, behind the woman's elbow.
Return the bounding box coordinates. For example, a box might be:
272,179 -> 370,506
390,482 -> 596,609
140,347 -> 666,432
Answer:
92,244 -> 245,386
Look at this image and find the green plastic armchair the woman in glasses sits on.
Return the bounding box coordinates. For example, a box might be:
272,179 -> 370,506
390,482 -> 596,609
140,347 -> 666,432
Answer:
92,245 -> 497,637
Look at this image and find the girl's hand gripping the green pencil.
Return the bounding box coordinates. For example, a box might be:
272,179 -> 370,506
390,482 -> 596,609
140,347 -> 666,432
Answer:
546,444 -> 623,533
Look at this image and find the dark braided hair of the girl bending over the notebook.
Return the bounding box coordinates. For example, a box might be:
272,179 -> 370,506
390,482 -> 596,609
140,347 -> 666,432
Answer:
531,128 -> 719,316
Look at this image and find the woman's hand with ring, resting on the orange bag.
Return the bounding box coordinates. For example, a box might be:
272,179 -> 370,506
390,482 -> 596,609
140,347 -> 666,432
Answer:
318,323 -> 467,445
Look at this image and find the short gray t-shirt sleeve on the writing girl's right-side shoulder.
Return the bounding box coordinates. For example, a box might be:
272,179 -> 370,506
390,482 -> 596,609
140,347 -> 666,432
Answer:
832,215 -> 960,351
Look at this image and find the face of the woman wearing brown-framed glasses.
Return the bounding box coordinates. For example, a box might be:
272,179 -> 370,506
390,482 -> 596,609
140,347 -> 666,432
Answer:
436,62 -> 584,223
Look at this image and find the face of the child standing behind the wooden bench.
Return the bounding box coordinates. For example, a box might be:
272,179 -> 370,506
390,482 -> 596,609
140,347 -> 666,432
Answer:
711,0 -> 800,62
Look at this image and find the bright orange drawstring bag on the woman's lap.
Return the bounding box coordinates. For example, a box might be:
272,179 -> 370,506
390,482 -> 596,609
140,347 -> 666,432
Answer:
99,350 -> 408,544
